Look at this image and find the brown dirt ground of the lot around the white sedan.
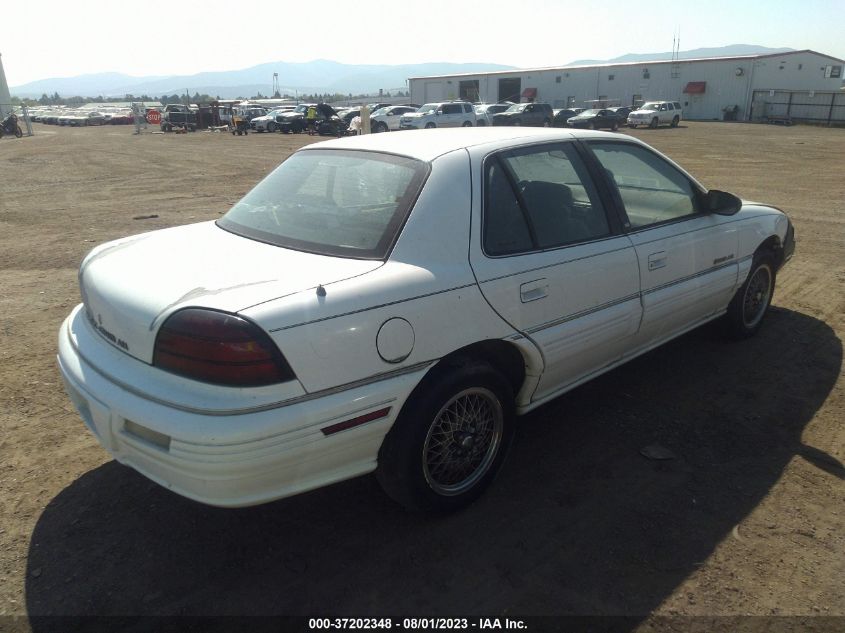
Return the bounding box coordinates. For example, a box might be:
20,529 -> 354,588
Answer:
0,123 -> 845,631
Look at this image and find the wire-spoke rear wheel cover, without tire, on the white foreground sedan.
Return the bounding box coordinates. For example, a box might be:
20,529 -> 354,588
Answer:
422,387 -> 504,496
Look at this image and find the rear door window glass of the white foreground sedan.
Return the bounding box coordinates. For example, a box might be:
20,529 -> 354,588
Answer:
483,143 -> 610,255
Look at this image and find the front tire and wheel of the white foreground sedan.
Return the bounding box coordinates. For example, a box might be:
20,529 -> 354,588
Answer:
725,252 -> 777,339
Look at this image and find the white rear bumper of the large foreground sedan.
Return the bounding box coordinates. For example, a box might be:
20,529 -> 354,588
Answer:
58,310 -> 425,507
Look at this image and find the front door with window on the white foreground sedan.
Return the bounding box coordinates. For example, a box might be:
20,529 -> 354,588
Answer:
587,141 -> 738,349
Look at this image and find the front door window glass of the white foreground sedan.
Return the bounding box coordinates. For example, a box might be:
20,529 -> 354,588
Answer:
590,143 -> 697,228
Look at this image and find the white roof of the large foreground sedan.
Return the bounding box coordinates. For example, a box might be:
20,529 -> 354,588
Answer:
300,126 -> 636,162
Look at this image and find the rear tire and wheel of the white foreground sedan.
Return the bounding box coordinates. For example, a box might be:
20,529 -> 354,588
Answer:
376,359 -> 513,512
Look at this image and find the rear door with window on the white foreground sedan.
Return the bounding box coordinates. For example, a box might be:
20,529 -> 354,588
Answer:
470,141 -> 641,401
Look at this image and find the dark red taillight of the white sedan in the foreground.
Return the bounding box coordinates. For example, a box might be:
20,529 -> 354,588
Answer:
153,308 -> 294,387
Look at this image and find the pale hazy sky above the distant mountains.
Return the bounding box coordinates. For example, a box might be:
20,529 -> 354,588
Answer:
0,0 -> 845,88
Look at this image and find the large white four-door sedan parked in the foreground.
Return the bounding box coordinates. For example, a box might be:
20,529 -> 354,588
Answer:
58,127 -> 794,511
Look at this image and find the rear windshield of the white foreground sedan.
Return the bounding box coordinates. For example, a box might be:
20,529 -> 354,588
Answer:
217,150 -> 428,259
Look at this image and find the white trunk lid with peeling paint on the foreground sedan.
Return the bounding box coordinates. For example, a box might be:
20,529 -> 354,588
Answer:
79,222 -> 382,363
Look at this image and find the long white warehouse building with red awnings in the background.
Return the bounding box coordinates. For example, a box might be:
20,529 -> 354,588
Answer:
408,50 -> 845,122
